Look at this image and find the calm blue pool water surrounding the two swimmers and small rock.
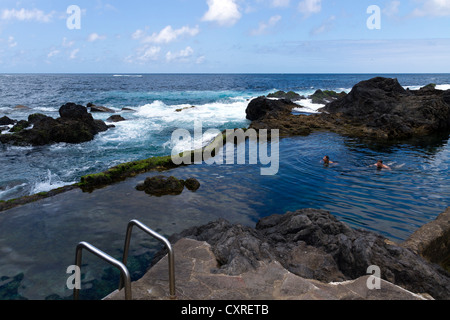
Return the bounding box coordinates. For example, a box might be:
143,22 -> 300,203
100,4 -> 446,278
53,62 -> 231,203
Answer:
0,133 -> 450,299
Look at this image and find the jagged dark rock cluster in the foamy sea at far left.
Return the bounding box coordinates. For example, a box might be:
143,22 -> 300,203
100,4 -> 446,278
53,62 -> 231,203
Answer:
0,103 -> 109,146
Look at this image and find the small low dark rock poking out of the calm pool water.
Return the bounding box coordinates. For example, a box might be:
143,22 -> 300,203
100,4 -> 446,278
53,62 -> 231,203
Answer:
136,176 -> 200,197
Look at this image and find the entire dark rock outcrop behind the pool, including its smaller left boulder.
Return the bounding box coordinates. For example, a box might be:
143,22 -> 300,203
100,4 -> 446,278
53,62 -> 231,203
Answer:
247,77 -> 450,141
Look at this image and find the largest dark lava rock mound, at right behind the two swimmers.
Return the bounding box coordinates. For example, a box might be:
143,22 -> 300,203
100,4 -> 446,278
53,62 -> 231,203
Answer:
321,77 -> 450,139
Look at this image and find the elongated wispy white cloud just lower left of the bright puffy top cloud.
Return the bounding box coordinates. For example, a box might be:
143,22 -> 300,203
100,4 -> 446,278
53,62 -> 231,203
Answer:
131,26 -> 200,44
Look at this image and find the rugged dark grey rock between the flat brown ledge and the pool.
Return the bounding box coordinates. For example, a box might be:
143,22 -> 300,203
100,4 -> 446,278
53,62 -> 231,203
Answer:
170,209 -> 450,299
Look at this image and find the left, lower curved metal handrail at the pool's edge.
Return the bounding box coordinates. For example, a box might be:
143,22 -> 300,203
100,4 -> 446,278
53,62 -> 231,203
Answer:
73,242 -> 132,300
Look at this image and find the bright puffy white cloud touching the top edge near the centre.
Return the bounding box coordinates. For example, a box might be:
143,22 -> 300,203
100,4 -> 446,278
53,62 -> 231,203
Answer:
202,0 -> 242,26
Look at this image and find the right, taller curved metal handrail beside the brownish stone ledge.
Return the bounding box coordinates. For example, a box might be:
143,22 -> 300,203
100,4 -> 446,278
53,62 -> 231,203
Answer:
119,220 -> 176,299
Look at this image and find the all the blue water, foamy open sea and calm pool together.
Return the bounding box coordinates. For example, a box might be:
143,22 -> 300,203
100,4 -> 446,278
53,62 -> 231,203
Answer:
0,74 -> 450,299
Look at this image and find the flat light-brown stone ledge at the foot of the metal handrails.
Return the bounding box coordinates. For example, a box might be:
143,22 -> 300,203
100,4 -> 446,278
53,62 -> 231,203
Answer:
104,238 -> 430,301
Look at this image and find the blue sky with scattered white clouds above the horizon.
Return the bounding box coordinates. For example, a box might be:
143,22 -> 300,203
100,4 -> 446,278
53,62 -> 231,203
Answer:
0,0 -> 450,73
